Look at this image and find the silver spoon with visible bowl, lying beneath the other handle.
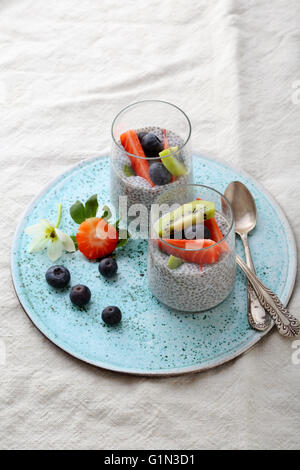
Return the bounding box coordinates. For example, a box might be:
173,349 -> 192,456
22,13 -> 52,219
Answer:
224,181 -> 271,331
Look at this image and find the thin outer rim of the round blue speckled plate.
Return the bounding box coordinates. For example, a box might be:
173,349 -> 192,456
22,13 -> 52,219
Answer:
10,149 -> 297,377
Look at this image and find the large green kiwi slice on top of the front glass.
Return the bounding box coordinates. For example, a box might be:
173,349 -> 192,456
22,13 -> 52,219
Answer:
154,200 -> 215,238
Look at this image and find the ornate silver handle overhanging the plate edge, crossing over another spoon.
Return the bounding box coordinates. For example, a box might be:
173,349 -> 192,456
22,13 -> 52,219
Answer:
236,255 -> 300,337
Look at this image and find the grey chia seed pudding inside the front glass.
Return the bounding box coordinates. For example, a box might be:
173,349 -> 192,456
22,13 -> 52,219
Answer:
148,212 -> 236,312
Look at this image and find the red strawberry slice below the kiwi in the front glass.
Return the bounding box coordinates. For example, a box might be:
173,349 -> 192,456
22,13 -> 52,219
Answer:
157,238 -> 221,264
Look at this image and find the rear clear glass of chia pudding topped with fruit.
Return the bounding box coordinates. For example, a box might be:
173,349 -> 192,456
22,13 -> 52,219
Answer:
110,100 -> 193,216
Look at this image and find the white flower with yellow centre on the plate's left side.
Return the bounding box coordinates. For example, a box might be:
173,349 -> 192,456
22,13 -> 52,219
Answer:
25,219 -> 75,261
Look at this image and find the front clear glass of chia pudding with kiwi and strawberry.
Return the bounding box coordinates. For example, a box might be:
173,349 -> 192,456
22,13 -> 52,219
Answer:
148,185 -> 236,312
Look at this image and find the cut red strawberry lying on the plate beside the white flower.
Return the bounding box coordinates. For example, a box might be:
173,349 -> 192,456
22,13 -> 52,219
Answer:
76,217 -> 119,259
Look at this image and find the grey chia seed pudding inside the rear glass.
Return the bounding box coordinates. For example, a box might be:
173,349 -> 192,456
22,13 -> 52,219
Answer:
110,126 -> 193,211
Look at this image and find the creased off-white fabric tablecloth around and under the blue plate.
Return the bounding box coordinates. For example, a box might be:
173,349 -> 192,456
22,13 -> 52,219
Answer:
0,0 -> 300,449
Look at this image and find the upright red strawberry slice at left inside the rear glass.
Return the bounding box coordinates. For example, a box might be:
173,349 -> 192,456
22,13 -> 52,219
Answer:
120,129 -> 154,186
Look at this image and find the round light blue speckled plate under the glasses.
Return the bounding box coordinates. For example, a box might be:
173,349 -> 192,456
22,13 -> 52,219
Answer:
12,155 -> 296,375
